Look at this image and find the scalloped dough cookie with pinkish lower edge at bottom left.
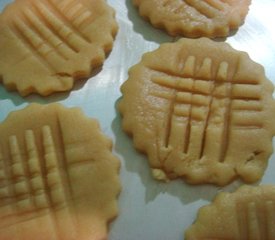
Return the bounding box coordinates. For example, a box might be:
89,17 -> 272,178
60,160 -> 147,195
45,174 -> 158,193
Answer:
0,104 -> 120,240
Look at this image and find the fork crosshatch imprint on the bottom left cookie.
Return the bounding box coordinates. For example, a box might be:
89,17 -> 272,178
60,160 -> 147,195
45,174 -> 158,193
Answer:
0,126 -> 75,239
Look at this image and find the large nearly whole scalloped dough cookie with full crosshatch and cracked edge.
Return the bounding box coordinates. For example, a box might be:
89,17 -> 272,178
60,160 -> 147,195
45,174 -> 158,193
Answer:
119,38 -> 275,185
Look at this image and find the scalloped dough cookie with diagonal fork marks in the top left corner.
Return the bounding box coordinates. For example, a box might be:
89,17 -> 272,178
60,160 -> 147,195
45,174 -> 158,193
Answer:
0,0 -> 118,96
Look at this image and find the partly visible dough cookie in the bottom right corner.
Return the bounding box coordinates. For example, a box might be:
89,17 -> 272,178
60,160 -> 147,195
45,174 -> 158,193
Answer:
185,185 -> 275,240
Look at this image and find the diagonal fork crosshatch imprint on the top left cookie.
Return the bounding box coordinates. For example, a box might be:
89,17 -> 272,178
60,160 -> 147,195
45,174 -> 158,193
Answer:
8,0 -> 103,73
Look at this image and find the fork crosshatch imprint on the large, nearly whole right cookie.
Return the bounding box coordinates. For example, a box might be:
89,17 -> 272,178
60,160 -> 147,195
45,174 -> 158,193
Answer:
151,56 -> 262,162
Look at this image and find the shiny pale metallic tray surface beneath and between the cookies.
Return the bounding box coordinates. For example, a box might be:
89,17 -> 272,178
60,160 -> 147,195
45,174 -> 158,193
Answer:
0,0 -> 275,240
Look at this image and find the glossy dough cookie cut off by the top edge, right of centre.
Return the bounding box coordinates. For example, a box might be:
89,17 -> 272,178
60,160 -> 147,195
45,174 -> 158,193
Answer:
133,0 -> 251,37
